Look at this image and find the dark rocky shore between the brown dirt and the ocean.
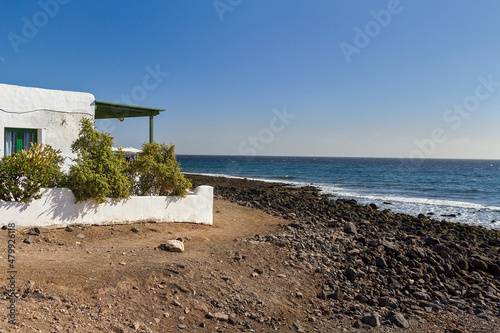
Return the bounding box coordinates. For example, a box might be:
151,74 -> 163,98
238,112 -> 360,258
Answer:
189,175 -> 500,332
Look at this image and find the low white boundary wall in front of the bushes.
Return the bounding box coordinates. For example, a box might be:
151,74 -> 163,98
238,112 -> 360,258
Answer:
0,186 -> 213,228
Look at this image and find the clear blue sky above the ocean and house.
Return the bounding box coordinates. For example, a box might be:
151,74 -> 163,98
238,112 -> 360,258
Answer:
0,0 -> 500,159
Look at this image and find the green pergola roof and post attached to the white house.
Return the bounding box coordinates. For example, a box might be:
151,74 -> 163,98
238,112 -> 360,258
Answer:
95,101 -> 165,143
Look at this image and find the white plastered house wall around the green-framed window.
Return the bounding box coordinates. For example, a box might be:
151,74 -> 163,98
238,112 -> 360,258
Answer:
0,84 -> 95,169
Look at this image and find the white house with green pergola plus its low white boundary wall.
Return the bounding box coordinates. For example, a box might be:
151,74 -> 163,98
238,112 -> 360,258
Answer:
0,84 -> 213,227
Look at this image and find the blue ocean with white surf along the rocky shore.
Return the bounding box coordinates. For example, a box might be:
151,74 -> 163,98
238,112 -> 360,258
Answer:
177,155 -> 500,230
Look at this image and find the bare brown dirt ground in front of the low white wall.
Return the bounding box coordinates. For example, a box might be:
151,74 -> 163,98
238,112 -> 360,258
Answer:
0,200 -> 498,332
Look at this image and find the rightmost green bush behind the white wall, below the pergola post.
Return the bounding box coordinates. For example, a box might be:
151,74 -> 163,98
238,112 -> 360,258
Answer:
127,143 -> 192,197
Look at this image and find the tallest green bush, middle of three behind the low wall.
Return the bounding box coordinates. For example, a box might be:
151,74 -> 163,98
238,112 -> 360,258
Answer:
68,118 -> 131,203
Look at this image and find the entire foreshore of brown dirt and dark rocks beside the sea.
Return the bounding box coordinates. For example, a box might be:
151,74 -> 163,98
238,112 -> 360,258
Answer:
0,175 -> 500,333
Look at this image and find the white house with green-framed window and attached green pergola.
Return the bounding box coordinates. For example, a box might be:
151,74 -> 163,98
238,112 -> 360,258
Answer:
0,84 -> 164,167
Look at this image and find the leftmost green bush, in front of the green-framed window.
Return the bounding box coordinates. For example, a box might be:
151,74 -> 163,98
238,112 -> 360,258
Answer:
0,143 -> 64,202
